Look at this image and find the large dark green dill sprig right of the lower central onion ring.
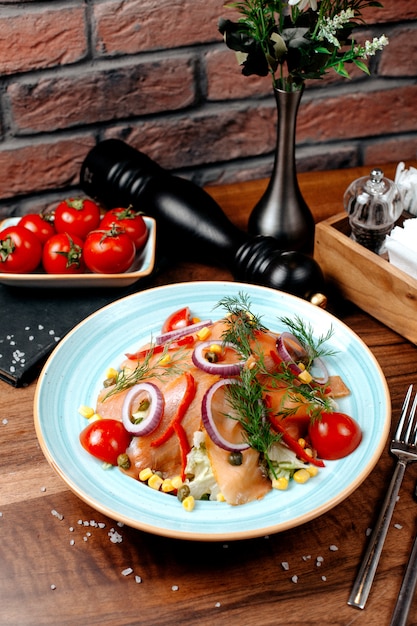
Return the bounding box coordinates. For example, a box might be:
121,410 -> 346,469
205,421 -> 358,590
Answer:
226,368 -> 281,477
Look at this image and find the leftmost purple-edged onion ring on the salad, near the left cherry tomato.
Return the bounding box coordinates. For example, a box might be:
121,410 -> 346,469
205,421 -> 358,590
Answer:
122,383 -> 165,436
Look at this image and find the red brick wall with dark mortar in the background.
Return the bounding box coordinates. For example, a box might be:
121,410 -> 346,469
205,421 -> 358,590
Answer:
0,0 -> 417,216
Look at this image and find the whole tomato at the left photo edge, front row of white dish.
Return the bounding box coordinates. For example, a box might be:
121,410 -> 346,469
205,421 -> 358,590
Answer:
0,224 -> 42,274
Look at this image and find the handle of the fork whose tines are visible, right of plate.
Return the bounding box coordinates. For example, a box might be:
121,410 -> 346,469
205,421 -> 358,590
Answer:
348,460 -> 406,609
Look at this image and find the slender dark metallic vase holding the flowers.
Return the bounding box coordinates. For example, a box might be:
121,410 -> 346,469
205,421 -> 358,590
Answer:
248,89 -> 315,254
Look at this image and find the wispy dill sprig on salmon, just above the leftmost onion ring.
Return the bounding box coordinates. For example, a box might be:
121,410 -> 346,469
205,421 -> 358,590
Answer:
104,344 -> 188,400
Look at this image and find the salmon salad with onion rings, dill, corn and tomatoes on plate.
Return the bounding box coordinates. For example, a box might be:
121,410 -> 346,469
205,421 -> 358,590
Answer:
80,293 -> 362,511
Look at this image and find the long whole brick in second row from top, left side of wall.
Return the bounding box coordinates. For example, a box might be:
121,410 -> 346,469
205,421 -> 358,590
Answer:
7,57 -> 195,133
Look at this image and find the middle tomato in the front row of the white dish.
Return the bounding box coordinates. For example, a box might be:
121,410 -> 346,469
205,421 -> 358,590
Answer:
42,233 -> 85,274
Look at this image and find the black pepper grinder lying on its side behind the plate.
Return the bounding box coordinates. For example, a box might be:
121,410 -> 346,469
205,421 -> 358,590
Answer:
81,139 -> 326,306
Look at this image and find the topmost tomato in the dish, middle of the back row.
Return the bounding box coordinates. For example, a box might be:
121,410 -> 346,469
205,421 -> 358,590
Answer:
54,198 -> 100,239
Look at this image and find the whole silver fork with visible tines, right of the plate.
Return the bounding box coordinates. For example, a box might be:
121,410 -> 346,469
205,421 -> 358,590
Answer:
348,385 -> 417,609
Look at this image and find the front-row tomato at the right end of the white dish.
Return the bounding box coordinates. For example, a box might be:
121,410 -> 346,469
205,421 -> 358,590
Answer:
84,227 -> 136,274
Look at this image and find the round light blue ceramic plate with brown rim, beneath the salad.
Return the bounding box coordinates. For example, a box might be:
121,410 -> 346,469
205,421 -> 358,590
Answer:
34,282 -> 391,541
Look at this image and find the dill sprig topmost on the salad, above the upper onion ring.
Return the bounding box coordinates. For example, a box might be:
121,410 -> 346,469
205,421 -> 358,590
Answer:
216,292 -> 266,358
